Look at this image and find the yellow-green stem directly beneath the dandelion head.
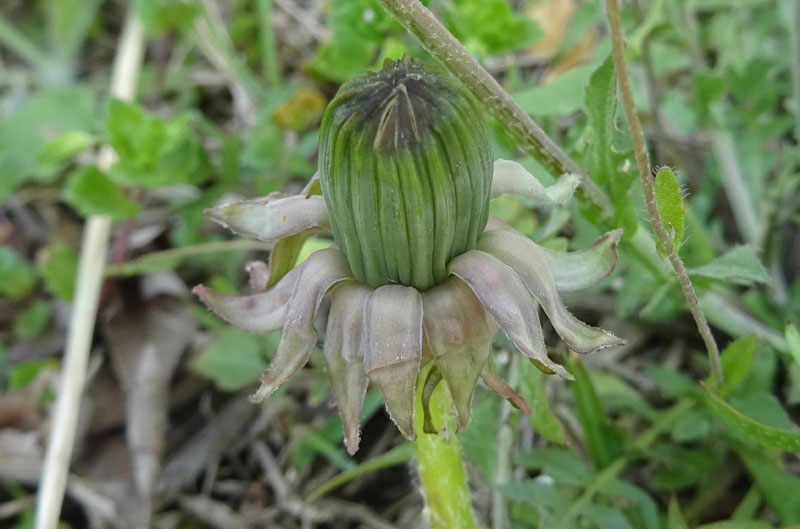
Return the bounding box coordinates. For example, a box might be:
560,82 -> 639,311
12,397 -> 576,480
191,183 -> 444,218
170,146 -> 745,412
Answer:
414,364 -> 475,529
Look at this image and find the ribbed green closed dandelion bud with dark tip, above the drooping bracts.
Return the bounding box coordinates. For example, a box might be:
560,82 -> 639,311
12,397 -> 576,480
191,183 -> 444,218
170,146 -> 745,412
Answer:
319,58 -> 492,290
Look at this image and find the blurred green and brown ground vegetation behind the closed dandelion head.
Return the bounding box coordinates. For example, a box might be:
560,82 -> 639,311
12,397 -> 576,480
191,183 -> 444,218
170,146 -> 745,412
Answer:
0,0 -> 800,529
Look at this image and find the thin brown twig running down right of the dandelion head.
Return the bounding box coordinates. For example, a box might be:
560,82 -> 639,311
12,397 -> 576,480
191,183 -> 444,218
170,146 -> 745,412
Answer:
608,0 -> 722,384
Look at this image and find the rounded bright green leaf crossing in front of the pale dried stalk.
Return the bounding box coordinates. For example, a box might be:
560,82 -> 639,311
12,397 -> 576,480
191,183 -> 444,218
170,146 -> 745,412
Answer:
64,165 -> 141,219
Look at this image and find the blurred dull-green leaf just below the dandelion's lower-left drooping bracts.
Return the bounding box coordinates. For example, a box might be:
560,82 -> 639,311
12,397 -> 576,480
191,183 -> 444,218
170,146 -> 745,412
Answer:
192,327 -> 267,391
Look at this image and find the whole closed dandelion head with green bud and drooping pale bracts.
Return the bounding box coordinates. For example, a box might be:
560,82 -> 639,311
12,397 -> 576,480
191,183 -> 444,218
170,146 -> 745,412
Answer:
195,59 -> 623,453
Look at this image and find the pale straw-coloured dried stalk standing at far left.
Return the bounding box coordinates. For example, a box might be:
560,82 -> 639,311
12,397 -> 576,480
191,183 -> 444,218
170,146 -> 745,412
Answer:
35,10 -> 144,529
